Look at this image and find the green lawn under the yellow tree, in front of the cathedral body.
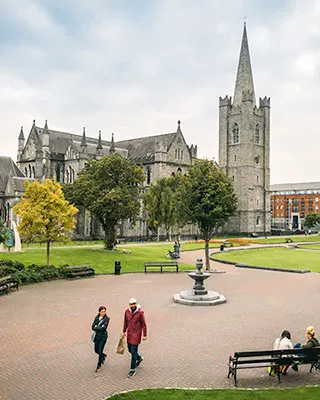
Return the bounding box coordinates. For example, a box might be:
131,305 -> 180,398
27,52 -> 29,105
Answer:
0,244 -> 195,273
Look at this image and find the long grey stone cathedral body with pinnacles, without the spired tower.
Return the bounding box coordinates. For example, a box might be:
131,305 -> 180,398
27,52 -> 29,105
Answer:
17,121 -> 197,240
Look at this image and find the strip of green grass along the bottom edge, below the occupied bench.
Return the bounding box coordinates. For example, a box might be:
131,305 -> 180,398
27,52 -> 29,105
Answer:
106,387 -> 320,400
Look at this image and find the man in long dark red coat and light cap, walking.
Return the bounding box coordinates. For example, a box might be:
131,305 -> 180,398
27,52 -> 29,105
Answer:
121,297 -> 147,378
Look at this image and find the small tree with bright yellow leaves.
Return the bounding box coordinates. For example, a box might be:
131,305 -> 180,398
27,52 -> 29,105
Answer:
13,179 -> 78,266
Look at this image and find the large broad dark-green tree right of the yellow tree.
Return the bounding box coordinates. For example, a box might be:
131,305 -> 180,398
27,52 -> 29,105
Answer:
64,154 -> 144,250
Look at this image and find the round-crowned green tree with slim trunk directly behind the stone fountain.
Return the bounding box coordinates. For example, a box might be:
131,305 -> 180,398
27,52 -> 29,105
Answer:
179,160 -> 237,270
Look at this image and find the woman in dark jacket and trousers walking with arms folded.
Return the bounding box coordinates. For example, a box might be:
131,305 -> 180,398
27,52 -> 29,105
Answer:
91,306 -> 110,372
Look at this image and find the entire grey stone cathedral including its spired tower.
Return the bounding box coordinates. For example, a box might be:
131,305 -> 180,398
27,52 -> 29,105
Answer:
0,25 -> 271,240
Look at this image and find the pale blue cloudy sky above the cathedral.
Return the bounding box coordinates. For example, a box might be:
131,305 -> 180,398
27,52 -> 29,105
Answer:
0,0 -> 320,183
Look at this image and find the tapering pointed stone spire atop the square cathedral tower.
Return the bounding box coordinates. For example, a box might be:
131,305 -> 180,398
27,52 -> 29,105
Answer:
233,23 -> 256,105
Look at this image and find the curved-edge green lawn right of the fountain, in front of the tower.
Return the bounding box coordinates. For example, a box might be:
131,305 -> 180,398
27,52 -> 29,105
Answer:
213,248 -> 320,272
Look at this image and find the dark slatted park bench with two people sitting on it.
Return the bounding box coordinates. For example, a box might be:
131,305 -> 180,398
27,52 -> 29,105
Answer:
228,347 -> 320,386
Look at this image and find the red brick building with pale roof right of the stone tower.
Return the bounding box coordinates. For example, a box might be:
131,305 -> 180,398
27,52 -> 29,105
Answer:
270,182 -> 320,230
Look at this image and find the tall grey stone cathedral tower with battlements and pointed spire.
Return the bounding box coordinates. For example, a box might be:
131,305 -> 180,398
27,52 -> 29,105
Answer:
219,24 -> 271,234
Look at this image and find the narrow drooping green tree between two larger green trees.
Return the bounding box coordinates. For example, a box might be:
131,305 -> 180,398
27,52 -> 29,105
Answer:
143,177 -> 176,240
